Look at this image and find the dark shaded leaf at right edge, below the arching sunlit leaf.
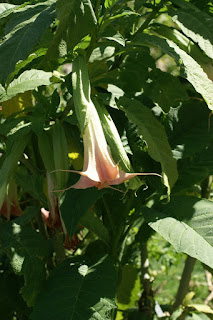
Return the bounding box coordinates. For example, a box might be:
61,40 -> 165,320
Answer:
164,100 -> 213,160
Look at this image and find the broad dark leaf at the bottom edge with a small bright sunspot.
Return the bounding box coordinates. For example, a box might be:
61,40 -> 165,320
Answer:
31,256 -> 116,320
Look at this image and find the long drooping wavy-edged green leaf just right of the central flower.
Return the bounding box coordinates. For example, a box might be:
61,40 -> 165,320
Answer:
119,97 -> 178,191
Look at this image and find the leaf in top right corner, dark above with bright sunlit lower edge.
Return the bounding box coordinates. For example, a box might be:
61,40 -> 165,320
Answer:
170,10 -> 213,59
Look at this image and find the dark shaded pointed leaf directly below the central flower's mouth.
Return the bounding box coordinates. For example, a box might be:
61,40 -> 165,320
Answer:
60,188 -> 107,238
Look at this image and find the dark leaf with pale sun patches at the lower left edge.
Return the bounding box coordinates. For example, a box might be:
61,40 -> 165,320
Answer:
0,207 -> 49,306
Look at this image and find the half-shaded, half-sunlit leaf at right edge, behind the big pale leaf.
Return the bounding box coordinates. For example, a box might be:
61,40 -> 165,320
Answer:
163,196 -> 213,246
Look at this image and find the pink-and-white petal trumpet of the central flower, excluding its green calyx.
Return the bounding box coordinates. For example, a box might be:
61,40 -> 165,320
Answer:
55,101 -> 161,191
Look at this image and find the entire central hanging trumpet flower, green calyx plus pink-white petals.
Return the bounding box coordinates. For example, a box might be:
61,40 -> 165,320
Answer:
58,55 -> 161,190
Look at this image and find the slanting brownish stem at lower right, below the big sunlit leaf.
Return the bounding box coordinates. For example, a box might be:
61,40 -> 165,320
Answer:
172,256 -> 196,311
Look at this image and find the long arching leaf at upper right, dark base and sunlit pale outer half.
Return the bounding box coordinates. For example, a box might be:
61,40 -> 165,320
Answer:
131,34 -> 213,110
